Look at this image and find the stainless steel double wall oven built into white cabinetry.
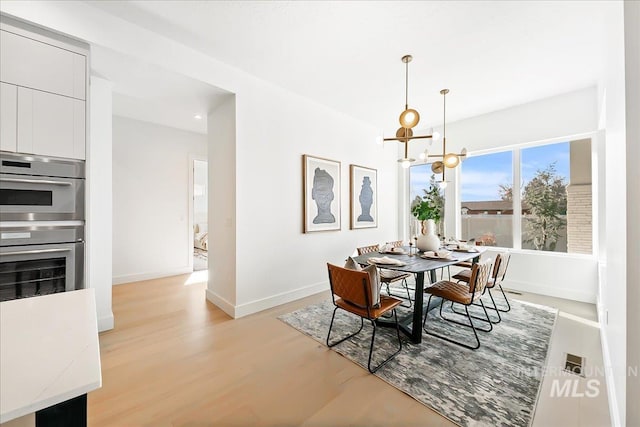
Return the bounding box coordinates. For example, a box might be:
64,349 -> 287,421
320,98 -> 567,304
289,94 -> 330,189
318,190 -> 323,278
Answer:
0,152 -> 85,301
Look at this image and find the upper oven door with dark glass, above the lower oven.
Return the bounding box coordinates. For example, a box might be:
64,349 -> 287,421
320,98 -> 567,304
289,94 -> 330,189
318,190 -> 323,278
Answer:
0,173 -> 84,221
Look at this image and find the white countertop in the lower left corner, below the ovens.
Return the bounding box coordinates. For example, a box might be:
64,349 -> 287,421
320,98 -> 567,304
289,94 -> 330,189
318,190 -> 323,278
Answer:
0,289 -> 102,423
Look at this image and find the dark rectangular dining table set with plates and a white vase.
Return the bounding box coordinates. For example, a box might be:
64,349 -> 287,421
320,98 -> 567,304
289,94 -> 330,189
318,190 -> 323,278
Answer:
354,246 -> 486,344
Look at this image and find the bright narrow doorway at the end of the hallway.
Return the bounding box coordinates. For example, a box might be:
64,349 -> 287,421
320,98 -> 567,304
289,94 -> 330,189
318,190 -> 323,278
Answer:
191,159 -> 209,271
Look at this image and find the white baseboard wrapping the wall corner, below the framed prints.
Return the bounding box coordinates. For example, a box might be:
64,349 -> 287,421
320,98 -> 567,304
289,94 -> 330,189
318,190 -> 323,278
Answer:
207,281 -> 329,319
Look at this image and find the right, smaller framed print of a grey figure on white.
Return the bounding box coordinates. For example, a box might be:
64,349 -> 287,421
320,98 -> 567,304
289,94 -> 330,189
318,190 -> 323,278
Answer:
349,165 -> 378,229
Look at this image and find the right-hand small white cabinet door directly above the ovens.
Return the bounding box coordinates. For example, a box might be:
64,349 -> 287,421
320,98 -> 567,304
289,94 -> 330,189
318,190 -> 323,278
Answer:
17,87 -> 85,160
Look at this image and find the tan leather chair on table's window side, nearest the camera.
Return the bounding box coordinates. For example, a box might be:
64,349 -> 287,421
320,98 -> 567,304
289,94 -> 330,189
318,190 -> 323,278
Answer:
422,260 -> 493,350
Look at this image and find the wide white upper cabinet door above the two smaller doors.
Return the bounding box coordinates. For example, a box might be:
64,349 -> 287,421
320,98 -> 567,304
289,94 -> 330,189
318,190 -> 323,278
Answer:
0,30 -> 86,100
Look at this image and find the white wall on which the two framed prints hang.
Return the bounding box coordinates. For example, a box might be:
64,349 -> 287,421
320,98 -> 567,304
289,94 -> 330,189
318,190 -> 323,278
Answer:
236,81 -> 398,315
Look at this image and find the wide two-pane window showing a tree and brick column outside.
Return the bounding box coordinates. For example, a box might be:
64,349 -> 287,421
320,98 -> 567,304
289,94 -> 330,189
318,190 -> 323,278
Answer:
460,139 -> 592,254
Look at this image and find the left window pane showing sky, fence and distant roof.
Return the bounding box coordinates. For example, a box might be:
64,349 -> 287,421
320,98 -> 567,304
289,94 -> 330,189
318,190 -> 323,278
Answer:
460,151 -> 513,248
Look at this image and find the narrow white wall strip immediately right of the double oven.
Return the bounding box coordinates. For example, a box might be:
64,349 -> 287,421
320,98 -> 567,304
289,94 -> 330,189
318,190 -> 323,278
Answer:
86,76 -> 114,331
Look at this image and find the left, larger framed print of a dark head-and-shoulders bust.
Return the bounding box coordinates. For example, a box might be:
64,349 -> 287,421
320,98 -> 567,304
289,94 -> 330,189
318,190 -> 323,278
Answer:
302,154 -> 341,233
